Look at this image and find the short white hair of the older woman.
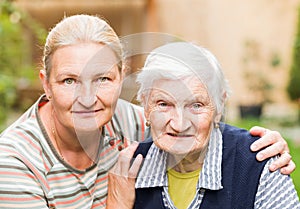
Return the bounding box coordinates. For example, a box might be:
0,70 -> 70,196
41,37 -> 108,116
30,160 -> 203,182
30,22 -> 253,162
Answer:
137,42 -> 230,114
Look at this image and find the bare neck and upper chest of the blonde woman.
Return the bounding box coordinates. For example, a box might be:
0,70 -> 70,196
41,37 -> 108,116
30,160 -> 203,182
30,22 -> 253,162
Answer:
40,103 -> 101,170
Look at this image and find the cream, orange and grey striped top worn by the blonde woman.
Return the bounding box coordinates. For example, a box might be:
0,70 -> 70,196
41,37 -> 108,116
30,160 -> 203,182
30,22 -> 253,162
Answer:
0,96 -> 149,209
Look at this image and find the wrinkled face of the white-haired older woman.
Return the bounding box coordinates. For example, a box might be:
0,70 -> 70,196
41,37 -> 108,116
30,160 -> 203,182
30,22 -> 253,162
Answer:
145,77 -> 215,155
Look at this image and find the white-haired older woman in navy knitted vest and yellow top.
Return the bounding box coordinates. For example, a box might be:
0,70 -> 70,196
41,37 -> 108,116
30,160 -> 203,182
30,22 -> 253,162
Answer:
109,42 -> 300,209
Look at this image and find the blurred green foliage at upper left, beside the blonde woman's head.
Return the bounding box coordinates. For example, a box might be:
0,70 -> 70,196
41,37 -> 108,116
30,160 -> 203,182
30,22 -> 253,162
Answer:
0,0 -> 46,126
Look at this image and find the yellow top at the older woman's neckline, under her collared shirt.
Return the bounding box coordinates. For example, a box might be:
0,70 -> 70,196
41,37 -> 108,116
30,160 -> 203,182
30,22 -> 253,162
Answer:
168,169 -> 201,209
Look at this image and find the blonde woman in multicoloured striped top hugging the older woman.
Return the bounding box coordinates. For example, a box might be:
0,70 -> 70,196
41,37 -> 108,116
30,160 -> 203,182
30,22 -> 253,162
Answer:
0,15 -> 295,209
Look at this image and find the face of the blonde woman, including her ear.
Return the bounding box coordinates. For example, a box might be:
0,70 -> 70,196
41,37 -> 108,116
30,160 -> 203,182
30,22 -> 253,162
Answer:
42,43 -> 122,131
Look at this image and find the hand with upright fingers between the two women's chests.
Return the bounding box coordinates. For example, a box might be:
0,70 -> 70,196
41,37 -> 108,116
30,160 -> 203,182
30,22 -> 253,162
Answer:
106,142 -> 143,209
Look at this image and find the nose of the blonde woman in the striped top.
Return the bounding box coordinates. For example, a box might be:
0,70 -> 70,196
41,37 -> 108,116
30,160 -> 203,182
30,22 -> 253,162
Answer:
77,84 -> 97,108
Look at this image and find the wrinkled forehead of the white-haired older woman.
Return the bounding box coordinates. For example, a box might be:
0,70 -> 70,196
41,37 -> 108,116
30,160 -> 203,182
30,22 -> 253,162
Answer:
151,77 -> 209,100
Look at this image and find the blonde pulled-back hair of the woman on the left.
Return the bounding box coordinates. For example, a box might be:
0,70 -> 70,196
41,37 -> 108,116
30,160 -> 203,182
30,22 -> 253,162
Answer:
43,14 -> 123,78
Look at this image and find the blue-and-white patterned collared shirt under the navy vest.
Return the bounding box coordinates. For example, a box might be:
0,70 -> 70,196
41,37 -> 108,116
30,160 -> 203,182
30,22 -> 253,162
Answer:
135,129 -> 300,209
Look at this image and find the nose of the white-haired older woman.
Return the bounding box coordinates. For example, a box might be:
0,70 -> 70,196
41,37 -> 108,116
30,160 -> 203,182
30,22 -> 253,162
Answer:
169,109 -> 191,132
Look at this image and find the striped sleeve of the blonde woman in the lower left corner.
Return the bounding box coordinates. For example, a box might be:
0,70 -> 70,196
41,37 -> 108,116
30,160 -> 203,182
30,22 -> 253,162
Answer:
0,143 -> 49,209
